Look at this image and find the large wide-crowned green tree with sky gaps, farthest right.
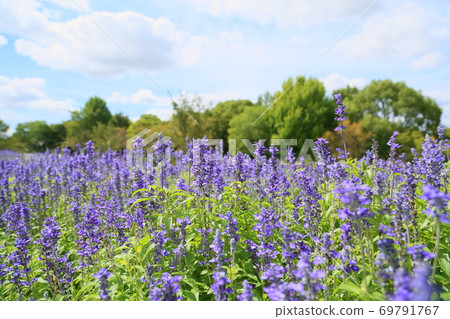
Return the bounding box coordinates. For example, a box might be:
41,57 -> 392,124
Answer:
334,80 -> 442,157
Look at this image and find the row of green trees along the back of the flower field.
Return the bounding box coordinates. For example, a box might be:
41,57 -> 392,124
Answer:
0,77 -> 442,157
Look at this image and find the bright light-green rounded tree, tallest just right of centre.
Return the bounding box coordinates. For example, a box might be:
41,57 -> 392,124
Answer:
268,77 -> 334,150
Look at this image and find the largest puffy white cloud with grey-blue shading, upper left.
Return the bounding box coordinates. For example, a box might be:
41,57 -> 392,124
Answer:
0,0 -> 206,76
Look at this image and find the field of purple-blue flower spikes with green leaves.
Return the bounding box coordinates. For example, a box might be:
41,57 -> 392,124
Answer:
0,98 -> 450,301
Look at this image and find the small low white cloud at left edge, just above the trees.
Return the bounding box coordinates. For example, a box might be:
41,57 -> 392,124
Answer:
0,75 -> 75,113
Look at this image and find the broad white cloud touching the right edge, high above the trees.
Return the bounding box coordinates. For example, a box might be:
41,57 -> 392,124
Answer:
337,2 -> 450,59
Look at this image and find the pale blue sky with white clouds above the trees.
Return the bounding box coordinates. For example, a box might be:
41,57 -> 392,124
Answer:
0,0 -> 450,132
